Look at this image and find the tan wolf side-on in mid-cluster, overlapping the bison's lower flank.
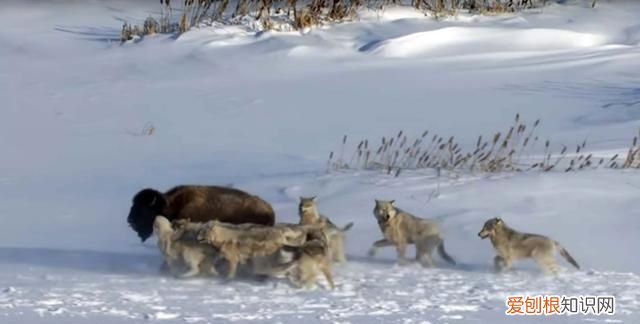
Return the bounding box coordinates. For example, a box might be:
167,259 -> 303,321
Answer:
196,220 -> 321,278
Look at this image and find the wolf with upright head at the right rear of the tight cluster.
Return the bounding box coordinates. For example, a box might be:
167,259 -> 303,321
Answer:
298,196 -> 353,263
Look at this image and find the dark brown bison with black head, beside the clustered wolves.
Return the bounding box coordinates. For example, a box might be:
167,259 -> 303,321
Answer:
127,186 -> 275,242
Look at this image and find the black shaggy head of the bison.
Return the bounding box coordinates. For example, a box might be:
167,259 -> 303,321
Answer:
127,188 -> 167,242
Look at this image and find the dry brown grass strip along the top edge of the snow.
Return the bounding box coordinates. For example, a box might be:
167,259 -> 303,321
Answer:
121,0 -> 556,42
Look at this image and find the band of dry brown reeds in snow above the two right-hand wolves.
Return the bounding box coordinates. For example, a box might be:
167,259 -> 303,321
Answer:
327,114 -> 640,176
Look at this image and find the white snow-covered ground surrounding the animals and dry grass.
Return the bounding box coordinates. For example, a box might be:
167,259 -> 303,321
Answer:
0,0 -> 640,323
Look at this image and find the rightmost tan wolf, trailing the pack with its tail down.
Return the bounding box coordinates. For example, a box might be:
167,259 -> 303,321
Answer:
478,217 -> 580,274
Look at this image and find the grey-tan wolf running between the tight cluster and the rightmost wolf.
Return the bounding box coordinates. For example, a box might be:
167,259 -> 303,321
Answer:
369,199 -> 456,267
